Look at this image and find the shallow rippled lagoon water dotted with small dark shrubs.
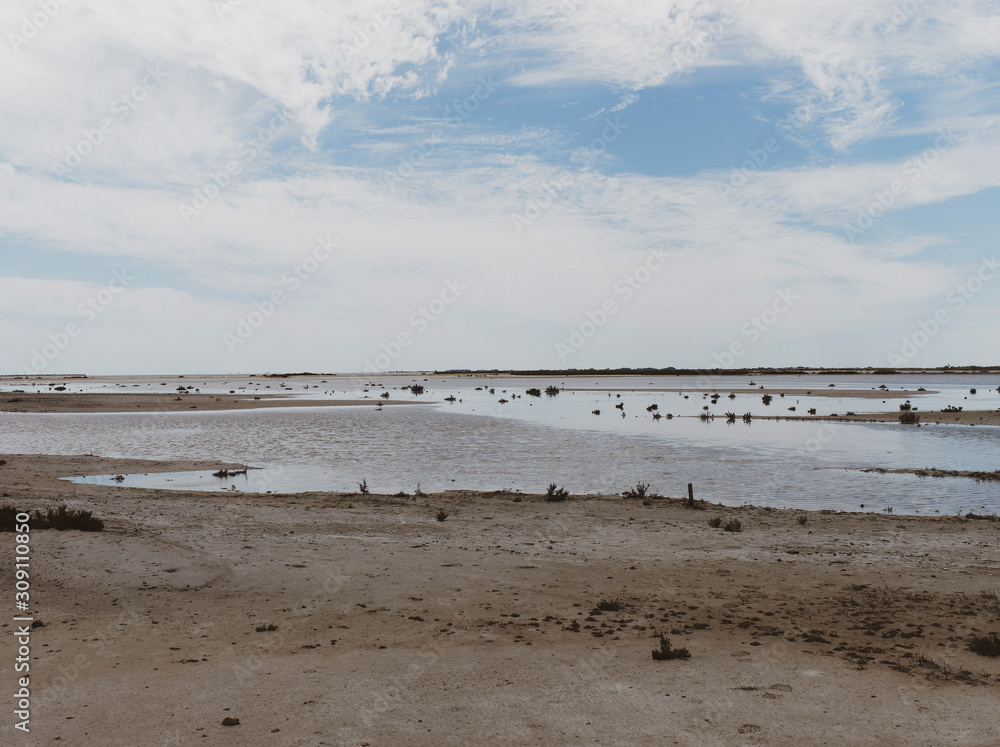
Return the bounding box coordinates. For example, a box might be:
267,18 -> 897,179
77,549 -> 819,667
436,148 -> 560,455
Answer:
0,376 -> 1000,514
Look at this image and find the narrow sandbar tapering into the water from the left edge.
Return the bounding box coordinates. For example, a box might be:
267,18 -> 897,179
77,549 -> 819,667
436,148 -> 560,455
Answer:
0,392 -> 433,412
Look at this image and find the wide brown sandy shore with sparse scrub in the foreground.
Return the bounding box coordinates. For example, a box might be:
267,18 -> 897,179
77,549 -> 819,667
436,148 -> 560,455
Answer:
0,456 -> 1000,747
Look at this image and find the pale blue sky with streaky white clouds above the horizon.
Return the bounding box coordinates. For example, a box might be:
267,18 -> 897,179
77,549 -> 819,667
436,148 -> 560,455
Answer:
0,0 -> 1000,375
